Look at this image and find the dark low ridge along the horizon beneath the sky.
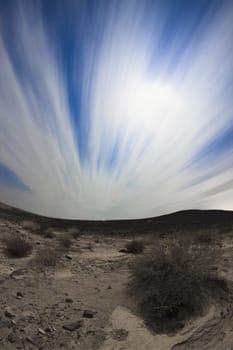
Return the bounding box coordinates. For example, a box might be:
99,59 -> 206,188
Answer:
0,203 -> 233,234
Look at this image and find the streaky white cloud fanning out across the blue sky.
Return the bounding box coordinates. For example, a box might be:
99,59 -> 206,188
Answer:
0,2 -> 233,219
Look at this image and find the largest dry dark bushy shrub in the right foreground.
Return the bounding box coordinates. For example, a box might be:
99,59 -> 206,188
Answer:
129,240 -> 227,332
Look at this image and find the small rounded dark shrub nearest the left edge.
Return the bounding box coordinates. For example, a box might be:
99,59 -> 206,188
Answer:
4,235 -> 32,258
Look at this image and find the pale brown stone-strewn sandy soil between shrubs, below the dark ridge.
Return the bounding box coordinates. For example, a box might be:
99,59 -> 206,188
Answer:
0,209 -> 233,350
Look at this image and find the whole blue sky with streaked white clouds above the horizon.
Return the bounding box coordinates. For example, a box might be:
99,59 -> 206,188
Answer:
0,0 -> 233,220
